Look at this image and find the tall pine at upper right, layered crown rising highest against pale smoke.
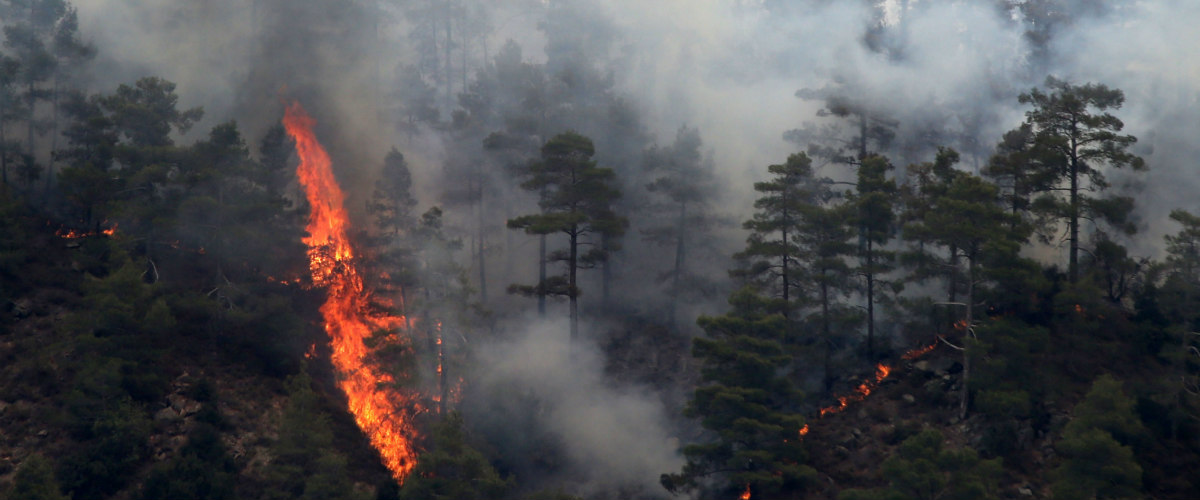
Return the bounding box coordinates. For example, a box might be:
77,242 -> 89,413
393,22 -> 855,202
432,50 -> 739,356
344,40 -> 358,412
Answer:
1020,77 -> 1146,283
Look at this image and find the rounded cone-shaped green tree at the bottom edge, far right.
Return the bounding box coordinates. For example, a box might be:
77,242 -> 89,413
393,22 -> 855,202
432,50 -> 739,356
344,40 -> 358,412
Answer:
1054,375 -> 1146,500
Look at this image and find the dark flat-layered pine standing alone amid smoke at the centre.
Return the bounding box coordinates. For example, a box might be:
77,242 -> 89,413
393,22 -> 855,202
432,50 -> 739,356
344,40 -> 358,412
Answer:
508,132 -> 629,342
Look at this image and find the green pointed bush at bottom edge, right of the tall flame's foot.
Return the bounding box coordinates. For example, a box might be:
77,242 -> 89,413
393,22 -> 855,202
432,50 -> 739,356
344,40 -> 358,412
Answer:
400,412 -> 512,500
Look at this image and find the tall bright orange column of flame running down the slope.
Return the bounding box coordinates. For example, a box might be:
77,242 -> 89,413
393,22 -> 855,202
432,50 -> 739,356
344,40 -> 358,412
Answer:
283,103 -> 419,482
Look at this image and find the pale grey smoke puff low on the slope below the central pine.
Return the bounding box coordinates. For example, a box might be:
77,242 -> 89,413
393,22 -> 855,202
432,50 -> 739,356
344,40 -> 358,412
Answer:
464,320 -> 683,496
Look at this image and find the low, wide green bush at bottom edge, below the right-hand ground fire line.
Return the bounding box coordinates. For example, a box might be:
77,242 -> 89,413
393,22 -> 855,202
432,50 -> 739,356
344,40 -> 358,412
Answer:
838,429 -> 1001,500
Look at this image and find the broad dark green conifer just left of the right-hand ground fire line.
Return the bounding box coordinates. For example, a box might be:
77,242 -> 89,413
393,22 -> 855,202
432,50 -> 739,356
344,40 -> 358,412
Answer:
661,304 -> 816,498
